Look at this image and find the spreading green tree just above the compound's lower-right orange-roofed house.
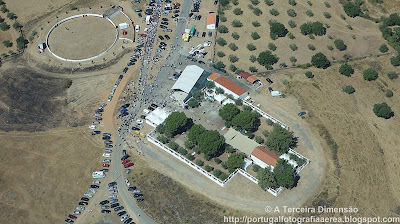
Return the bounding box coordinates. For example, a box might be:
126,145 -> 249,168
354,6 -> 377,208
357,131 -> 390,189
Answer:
265,124 -> 296,155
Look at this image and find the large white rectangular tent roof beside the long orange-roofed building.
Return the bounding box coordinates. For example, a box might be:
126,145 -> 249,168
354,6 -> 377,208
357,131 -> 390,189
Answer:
171,65 -> 204,93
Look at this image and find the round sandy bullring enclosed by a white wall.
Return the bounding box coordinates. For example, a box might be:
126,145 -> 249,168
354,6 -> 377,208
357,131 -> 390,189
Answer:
46,14 -> 118,62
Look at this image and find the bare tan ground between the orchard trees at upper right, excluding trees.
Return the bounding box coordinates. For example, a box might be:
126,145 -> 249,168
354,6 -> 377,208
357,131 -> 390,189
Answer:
215,1 -> 385,71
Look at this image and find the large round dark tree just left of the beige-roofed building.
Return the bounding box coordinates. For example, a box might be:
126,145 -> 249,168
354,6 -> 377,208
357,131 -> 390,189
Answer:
198,130 -> 225,156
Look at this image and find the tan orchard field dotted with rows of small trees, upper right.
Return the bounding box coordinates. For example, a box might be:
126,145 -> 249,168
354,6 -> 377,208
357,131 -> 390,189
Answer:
215,0 -> 385,72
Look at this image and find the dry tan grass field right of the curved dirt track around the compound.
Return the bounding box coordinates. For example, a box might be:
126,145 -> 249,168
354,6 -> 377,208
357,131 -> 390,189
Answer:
263,53 -> 400,216
